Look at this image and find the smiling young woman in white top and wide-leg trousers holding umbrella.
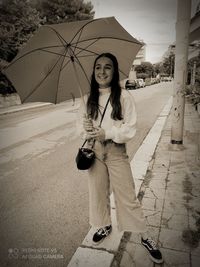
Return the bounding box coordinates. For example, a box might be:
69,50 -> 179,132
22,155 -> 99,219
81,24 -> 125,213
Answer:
77,53 -> 163,263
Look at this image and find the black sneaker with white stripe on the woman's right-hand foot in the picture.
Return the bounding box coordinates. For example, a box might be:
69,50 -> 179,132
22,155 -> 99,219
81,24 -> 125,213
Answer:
141,238 -> 163,263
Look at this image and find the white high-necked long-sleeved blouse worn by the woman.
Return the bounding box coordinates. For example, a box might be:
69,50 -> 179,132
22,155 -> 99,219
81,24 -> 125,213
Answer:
77,88 -> 137,144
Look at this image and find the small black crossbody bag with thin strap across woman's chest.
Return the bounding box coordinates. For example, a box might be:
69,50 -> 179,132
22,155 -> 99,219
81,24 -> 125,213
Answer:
76,96 -> 110,170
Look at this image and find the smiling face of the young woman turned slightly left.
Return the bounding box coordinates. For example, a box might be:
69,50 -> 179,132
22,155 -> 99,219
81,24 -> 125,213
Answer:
94,57 -> 114,88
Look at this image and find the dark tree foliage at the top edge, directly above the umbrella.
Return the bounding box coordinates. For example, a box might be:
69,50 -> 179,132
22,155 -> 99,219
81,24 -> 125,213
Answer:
35,0 -> 94,24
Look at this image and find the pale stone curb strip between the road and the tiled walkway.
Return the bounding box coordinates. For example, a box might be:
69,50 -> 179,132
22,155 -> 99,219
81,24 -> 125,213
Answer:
67,96 -> 173,267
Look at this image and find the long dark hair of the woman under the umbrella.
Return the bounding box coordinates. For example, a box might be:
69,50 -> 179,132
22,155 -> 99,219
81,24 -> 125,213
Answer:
87,53 -> 122,120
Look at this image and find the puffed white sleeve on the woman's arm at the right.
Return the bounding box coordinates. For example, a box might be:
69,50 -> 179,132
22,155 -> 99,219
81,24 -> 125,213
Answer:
102,90 -> 137,143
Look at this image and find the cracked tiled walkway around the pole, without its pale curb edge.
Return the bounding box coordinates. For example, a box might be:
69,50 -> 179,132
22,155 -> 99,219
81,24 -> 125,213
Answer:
115,104 -> 200,267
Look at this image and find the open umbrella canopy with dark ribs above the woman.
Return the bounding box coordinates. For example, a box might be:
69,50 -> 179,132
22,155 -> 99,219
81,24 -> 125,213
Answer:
4,17 -> 142,103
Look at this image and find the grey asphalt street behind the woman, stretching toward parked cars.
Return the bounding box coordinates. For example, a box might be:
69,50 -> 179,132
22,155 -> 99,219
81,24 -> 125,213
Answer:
0,82 -> 173,267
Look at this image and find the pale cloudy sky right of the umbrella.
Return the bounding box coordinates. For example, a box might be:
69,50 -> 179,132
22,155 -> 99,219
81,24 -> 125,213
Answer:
90,0 -> 200,63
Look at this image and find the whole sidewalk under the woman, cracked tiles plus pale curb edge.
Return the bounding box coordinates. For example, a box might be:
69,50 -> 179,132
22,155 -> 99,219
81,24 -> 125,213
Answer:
68,99 -> 200,267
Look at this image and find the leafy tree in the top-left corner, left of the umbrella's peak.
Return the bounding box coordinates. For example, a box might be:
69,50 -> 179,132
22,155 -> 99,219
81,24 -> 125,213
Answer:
0,0 -> 41,62
